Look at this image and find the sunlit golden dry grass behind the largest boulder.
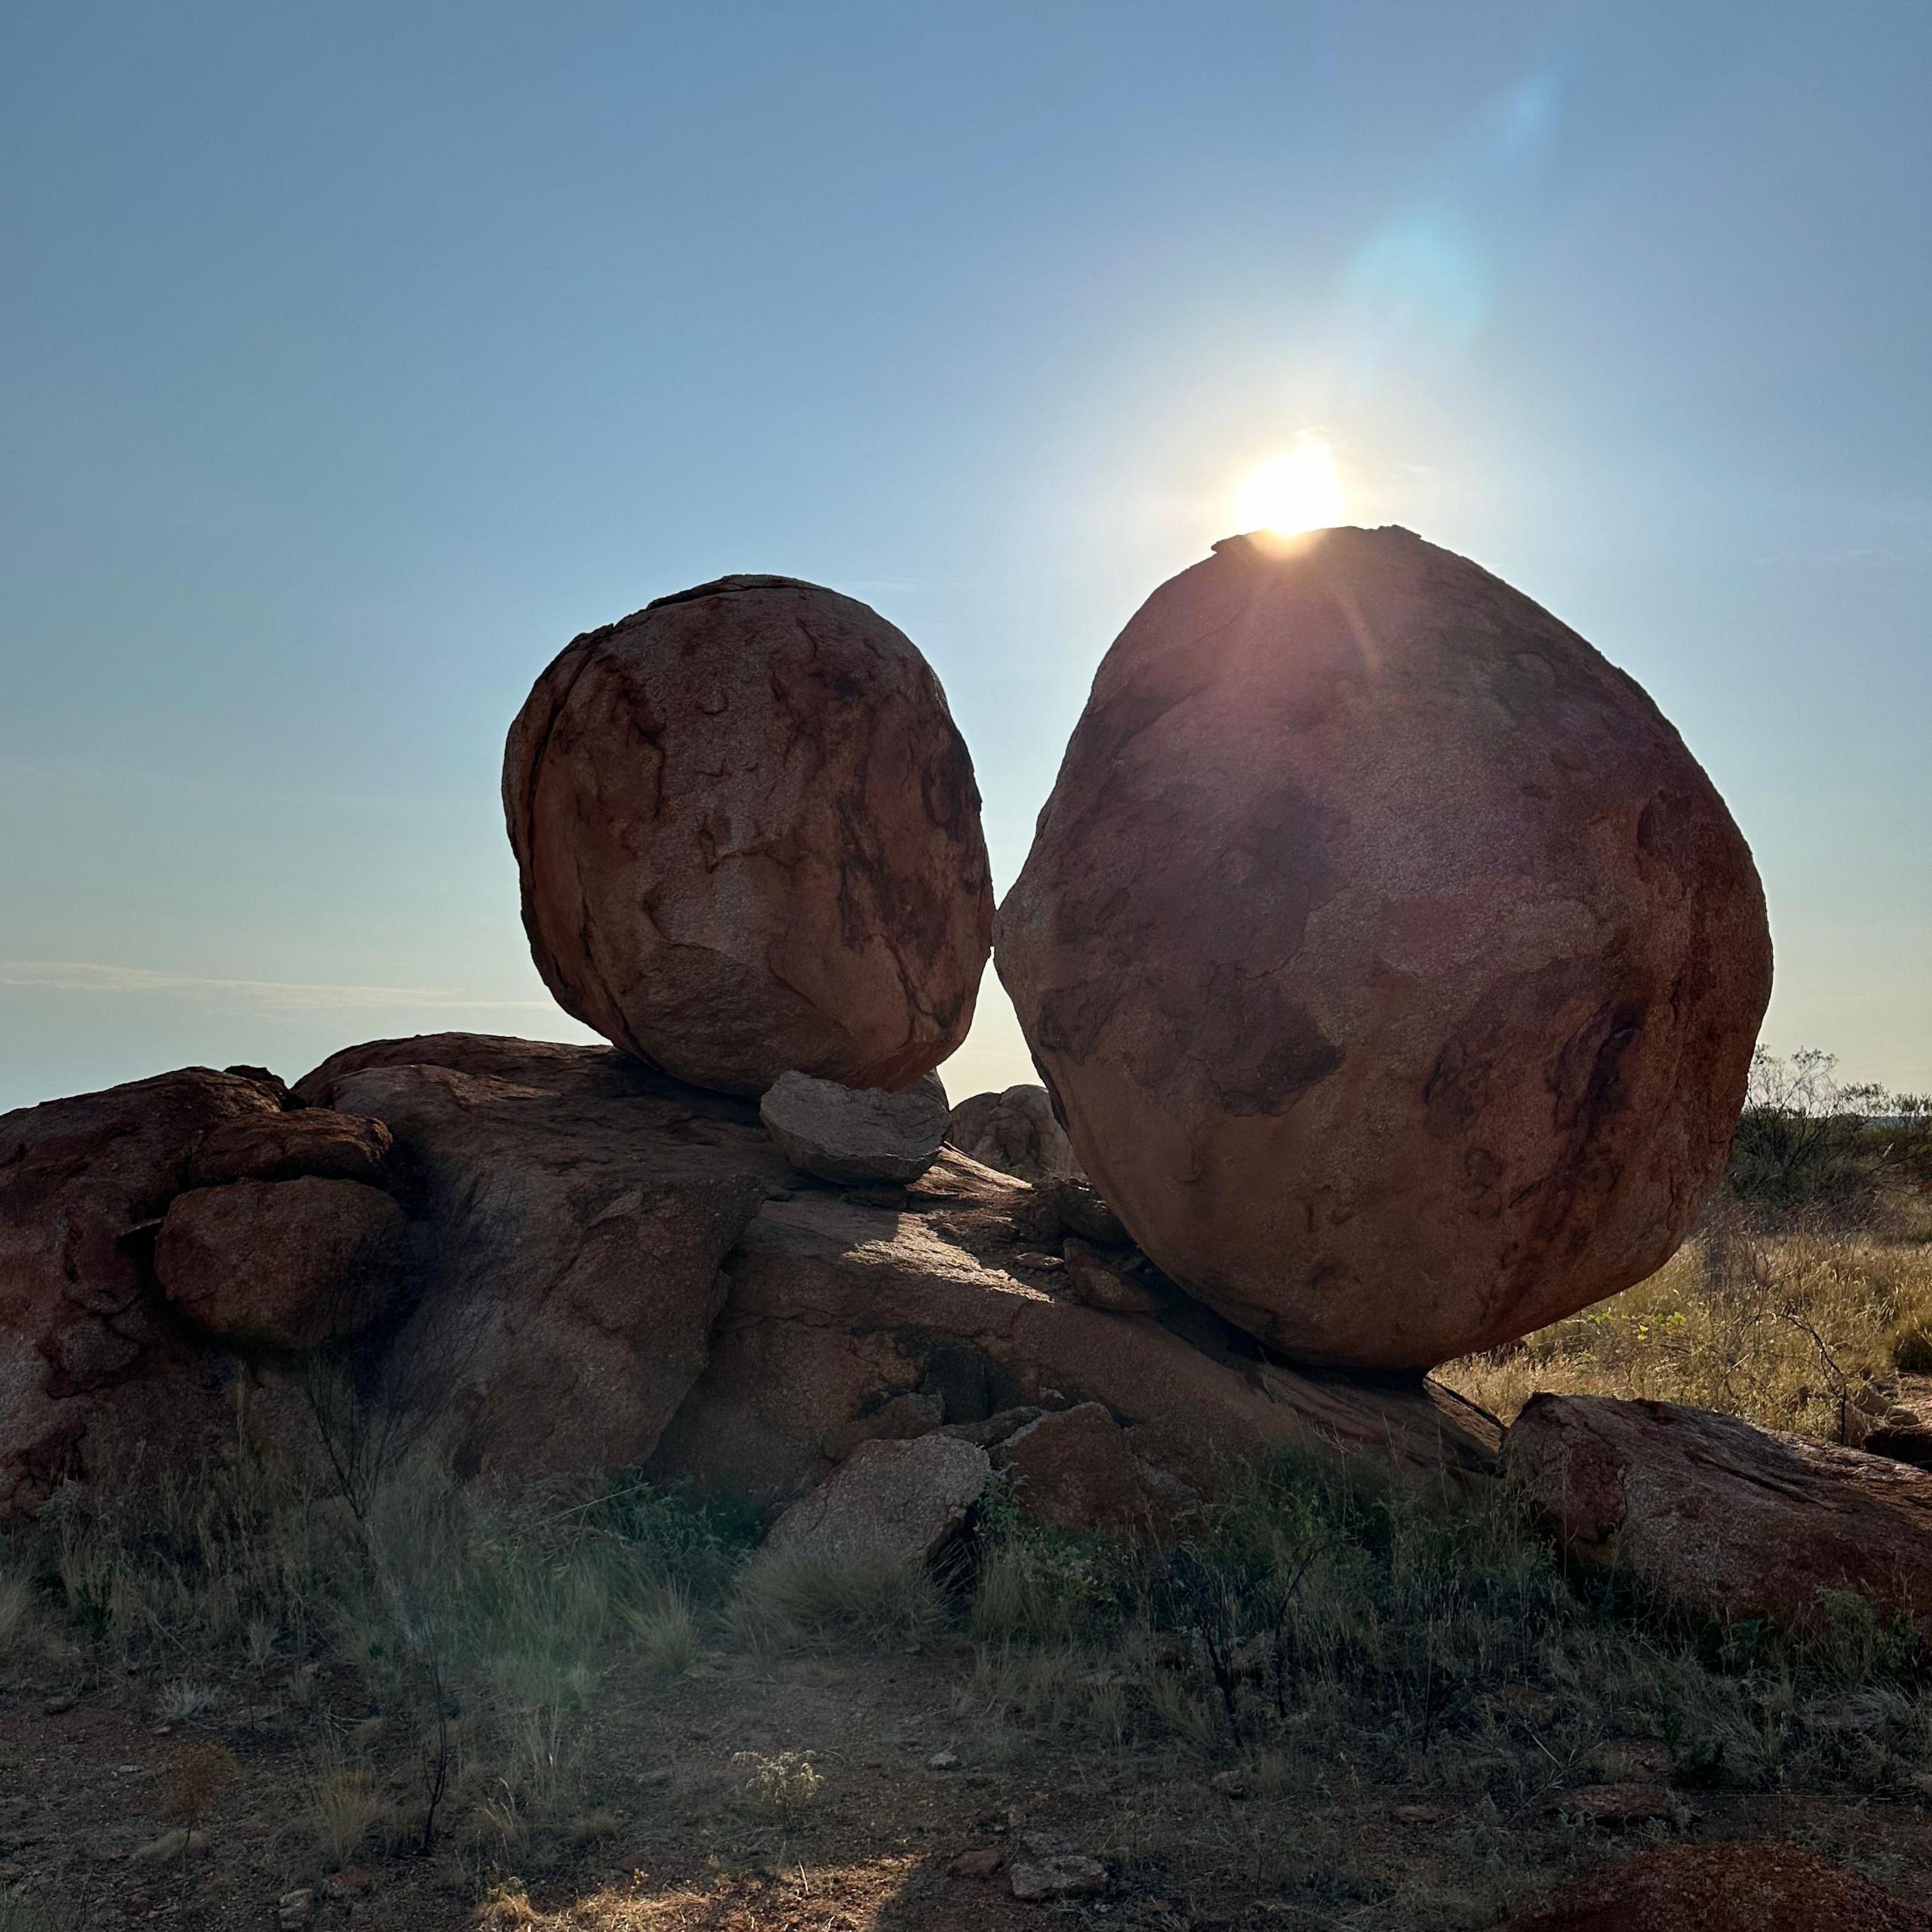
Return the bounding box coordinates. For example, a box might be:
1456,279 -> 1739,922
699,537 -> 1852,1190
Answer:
1438,1210 -> 1932,1439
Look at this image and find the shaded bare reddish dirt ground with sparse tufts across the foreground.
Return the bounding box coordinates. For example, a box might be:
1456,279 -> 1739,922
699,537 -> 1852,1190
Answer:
0,1644 -> 1932,1932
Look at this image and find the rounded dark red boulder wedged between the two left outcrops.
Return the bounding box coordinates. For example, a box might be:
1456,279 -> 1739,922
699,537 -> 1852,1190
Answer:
155,1174 -> 410,1349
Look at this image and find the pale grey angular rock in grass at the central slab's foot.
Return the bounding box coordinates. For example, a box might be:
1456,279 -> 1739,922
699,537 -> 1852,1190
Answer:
765,1435 -> 993,1569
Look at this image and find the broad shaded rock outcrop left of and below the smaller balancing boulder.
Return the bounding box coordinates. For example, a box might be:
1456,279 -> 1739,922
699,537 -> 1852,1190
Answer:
297,1034 -> 790,1476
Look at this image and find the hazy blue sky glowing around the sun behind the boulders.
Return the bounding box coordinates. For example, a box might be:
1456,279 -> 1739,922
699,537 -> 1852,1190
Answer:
0,0 -> 1932,1107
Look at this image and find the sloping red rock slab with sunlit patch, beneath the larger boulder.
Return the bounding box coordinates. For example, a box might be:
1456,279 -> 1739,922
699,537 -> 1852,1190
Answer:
651,1148 -> 1497,1497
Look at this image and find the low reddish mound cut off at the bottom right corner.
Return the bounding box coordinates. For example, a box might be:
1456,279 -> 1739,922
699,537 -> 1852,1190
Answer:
1500,1841 -> 1932,1932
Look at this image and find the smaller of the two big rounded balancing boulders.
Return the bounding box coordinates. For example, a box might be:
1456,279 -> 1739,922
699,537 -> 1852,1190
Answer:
503,576 -> 993,1094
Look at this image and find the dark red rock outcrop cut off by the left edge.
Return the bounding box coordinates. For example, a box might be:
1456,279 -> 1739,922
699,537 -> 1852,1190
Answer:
0,1066 -> 280,1517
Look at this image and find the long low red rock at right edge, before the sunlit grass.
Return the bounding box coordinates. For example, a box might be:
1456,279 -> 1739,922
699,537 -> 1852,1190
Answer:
1505,1395 -> 1932,1635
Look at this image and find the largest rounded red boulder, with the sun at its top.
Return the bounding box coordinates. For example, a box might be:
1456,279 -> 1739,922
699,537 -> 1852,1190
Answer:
999,529 -> 1772,1367
